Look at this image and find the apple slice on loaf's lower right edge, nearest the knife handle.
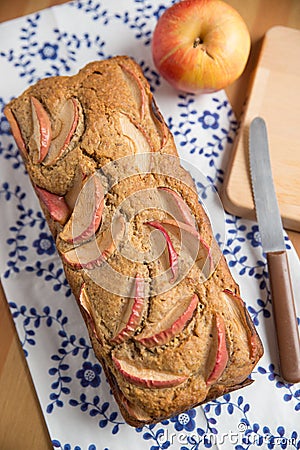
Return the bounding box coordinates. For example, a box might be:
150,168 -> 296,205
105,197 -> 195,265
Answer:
223,289 -> 259,359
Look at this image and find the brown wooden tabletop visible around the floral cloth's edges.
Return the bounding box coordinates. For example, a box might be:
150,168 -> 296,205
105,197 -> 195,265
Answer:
0,0 -> 300,450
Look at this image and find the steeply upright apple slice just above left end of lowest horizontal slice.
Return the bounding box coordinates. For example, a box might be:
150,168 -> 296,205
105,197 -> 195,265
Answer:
111,275 -> 145,344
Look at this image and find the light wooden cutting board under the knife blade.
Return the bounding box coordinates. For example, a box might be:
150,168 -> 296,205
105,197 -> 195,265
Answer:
220,26 -> 300,231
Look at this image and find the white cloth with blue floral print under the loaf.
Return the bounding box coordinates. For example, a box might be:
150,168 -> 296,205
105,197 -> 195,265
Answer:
0,0 -> 300,450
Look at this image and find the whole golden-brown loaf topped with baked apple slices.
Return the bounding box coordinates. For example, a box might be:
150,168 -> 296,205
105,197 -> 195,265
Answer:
5,56 -> 263,426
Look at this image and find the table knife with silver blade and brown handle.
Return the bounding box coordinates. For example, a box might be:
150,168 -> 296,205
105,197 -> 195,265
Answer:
249,117 -> 300,383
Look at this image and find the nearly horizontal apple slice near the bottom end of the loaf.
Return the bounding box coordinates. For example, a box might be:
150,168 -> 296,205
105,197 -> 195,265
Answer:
112,356 -> 188,389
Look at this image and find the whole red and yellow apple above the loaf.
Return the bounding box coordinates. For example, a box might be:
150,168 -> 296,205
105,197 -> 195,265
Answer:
152,0 -> 251,93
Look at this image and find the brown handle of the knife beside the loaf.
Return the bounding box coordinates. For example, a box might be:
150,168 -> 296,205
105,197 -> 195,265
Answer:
267,250 -> 300,383
